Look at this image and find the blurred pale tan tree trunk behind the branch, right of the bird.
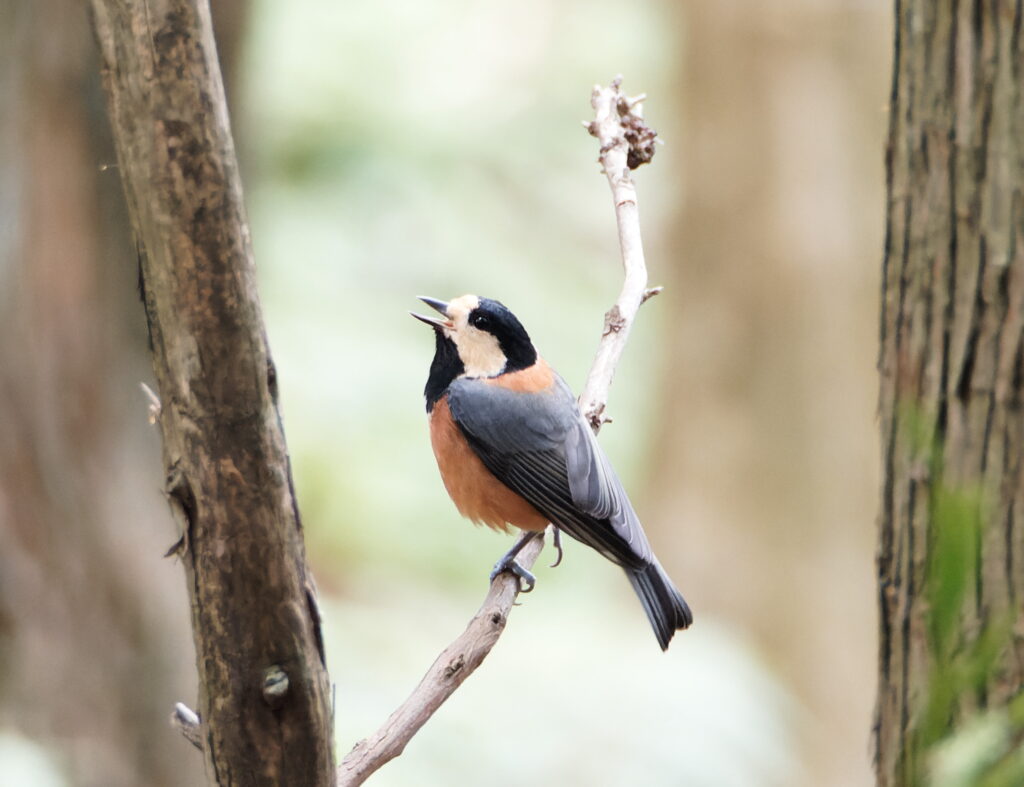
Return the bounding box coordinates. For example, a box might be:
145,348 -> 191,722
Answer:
646,0 -> 889,787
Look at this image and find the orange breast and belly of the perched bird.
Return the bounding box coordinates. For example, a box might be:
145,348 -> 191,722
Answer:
430,397 -> 548,531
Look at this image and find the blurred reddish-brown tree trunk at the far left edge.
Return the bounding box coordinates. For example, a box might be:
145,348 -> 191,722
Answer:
0,0 -> 241,787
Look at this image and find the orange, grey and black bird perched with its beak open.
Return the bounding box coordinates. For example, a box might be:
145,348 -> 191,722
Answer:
413,295 -> 693,650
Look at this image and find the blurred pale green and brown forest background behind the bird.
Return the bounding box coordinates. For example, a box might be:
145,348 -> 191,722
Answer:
0,0 -> 891,787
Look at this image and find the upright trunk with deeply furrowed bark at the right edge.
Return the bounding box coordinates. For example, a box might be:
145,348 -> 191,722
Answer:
876,0 -> 1024,785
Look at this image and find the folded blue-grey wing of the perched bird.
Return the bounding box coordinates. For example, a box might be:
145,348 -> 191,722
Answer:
447,376 -> 652,567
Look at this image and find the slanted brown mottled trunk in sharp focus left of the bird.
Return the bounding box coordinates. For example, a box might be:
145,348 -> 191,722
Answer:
91,0 -> 334,785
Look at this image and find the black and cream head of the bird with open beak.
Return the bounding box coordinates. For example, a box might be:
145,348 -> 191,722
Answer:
413,295 -> 537,399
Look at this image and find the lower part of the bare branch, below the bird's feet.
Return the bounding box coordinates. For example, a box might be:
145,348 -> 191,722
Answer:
338,538 -> 544,787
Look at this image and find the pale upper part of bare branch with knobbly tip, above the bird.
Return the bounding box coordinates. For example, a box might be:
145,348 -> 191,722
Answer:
580,77 -> 662,432
